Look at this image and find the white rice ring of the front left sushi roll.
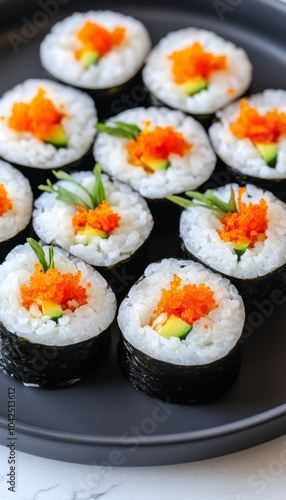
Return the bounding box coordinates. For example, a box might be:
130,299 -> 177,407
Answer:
0,243 -> 116,346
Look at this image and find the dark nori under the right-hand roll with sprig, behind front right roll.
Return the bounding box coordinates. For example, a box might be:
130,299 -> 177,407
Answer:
180,238 -> 286,310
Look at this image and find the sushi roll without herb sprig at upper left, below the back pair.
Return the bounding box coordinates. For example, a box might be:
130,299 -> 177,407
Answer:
0,79 -> 97,190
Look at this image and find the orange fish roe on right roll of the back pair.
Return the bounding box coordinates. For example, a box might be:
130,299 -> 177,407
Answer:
168,42 -> 227,84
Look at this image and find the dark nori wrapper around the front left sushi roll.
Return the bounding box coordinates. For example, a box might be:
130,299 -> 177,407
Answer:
0,322 -> 110,389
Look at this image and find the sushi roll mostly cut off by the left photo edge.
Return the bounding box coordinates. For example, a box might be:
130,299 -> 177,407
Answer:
0,160 -> 33,257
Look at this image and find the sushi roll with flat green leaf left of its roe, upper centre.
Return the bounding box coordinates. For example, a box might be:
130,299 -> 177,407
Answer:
94,107 -> 216,200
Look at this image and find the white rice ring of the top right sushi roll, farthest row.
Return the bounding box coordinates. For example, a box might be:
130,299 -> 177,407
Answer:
143,28 -> 252,114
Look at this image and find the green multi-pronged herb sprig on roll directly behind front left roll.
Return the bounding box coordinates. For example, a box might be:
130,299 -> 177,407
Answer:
38,163 -> 106,210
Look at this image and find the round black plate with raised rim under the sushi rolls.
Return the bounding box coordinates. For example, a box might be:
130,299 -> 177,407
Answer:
0,0 -> 286,466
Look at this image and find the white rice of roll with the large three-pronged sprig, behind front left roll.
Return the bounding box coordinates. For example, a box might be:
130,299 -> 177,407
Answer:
33,172 -> 153,266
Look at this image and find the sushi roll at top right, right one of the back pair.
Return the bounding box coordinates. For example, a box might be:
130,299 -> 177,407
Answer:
142,28 -> 252,115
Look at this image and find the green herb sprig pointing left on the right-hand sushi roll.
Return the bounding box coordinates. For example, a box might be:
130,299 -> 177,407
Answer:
167,186 -> 237,215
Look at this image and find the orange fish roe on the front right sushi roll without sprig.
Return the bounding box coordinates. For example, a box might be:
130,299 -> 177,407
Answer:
154,274 -> 217,325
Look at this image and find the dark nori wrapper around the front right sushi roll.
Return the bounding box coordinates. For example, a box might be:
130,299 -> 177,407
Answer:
118,338 -> 242,404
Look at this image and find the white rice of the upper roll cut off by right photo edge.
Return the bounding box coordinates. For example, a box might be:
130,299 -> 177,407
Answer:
209,89 -> 286,179
